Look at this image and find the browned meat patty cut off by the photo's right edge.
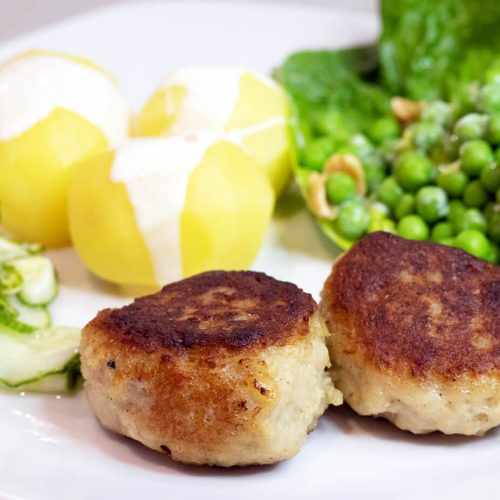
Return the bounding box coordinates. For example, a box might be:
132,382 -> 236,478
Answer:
320,232 -> 500,435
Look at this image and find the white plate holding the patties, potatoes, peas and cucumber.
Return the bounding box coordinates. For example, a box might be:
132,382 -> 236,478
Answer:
0,2 -> 500,500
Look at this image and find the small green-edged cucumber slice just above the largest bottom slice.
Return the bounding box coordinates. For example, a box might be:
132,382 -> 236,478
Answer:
0,296 -> 51,333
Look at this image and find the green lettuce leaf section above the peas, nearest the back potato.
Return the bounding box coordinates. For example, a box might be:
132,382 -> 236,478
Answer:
276,47 -> 389,152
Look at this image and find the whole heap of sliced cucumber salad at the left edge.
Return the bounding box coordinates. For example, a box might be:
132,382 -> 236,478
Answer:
0,236 -> 80,393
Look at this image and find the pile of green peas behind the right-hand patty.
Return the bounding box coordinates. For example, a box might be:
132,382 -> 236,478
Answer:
302,79 -> 500,264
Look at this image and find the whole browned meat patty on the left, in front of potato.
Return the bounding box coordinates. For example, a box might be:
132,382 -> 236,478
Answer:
80,271 -> 342,467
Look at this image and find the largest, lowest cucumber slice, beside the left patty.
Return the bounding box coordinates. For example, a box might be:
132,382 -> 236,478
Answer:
0,327 -> 80,392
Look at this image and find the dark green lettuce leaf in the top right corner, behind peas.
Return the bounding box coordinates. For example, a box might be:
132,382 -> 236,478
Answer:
378,0 -> 500,100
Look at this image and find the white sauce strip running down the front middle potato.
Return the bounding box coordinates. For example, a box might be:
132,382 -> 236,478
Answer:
111,134 -> 216,285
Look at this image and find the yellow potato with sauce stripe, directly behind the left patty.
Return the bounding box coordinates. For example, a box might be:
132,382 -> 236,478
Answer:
69,134 -> 274,289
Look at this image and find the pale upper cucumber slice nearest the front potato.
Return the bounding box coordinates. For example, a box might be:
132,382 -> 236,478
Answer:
5,255 -> 58,305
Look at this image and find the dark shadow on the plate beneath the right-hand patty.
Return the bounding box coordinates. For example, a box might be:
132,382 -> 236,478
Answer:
323,405 -> 499,447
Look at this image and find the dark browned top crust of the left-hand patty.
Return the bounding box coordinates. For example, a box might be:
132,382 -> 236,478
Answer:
94,271 -> 316,352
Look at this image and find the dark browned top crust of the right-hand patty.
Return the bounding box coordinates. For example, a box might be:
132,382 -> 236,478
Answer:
322,233 -> 500,380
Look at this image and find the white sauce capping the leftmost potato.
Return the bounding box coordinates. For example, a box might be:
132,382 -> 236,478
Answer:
0,54 -> 129,147
